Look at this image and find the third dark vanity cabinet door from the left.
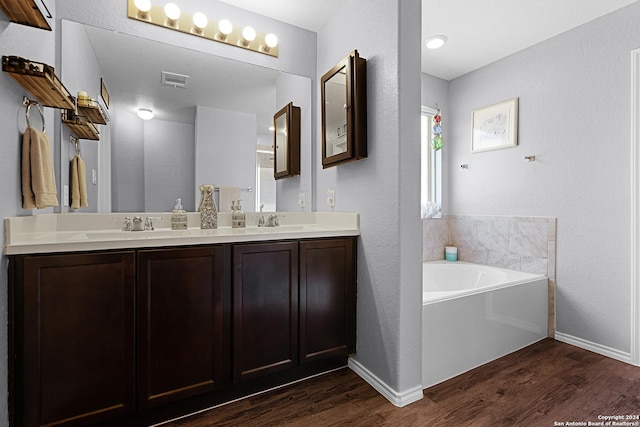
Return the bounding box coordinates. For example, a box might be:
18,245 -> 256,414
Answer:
233,242 -> 298,382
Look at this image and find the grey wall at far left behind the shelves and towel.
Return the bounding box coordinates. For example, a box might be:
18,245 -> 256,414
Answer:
0,0 -> 60,425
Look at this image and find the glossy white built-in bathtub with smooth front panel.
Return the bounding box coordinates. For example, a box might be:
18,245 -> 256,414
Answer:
422,261 -> 548,388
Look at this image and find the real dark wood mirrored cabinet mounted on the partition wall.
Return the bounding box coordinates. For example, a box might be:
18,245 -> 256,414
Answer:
320,50 -> 367,169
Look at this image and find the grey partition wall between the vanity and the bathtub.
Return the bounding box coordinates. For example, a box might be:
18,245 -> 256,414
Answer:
314,0 -> 422,400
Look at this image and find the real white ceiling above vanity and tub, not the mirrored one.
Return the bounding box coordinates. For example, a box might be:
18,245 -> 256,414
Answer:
220,0 -> 637,80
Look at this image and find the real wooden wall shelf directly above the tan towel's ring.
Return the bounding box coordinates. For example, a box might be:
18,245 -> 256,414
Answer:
0,56 -> 76,109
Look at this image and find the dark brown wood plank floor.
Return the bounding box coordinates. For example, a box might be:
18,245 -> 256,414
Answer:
159,339 -> 640,427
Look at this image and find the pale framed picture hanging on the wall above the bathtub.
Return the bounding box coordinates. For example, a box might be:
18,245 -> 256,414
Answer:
471,98 -> 518,153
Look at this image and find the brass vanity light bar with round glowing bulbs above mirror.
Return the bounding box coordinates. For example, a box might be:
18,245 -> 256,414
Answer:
127,0 -> 278,58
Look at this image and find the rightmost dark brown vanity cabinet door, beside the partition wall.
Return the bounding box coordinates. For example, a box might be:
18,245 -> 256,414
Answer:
300,238 -> 356,363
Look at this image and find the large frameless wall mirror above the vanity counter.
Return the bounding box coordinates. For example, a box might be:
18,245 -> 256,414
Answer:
61,20 -> 311,212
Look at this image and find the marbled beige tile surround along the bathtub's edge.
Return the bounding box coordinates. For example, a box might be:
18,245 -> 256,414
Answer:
422,215 -> 557,336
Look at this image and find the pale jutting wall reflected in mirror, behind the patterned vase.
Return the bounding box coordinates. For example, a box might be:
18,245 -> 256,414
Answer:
193,106 -> 258,211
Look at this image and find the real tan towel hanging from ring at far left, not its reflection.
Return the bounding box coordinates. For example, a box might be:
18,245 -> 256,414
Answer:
21,126 -> 58,209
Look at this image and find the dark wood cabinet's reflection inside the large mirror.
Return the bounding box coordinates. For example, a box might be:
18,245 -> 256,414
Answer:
273,102 -> 300,179
